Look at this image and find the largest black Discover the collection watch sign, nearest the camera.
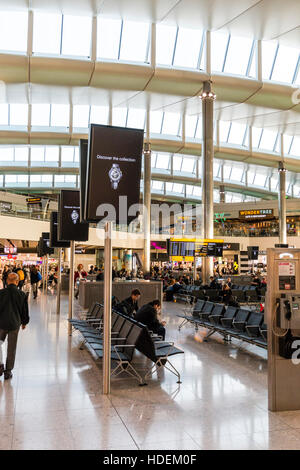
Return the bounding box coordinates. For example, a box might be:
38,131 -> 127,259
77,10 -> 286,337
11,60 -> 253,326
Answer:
83,124 -> 144,224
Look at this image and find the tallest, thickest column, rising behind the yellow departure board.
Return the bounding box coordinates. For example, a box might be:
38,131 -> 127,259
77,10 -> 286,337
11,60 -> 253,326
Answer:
201,81 -> 216,283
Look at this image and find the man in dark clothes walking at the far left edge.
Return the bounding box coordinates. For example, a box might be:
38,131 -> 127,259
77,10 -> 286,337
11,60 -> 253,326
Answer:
0,273 -> 29,380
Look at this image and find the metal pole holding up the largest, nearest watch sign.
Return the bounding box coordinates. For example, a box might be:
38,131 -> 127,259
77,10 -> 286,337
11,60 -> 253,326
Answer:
103,222 -> 112,395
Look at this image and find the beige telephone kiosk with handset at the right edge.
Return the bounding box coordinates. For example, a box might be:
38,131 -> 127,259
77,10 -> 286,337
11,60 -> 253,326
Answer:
265,248 -> 300,411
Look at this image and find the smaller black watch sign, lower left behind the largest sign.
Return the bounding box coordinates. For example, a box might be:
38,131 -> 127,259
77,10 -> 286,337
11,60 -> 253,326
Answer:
58,189 -> 89,242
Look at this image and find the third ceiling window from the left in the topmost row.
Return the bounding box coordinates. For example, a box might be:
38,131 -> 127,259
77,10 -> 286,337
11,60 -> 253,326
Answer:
61,15 -> 92,57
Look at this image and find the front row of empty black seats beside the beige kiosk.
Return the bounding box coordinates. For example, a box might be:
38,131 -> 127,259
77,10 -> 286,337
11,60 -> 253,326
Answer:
177,300 -> 267,348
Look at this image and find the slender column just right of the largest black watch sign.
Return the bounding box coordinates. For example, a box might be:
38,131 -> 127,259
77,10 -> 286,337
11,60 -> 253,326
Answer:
144,142 -> 151,272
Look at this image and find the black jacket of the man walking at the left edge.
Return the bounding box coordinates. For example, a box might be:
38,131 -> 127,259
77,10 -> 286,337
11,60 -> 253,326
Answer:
0,284 -> 29,331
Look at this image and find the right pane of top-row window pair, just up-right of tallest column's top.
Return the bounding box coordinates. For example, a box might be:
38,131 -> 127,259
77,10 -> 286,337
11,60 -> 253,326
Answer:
224,36 -> 253,75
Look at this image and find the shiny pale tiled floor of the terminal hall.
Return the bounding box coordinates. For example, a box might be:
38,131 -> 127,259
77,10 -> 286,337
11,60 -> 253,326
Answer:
0,294 -> 300,450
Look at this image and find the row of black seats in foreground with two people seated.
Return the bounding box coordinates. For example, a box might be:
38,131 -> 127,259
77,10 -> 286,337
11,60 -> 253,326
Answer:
69,302 -> 183,385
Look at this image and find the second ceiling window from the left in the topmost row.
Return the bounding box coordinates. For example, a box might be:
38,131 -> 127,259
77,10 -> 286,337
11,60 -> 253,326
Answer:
32,12 -> 62,55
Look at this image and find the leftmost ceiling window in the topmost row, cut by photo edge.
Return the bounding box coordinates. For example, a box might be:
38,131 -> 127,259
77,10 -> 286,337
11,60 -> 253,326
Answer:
0,10 -> 28,52
